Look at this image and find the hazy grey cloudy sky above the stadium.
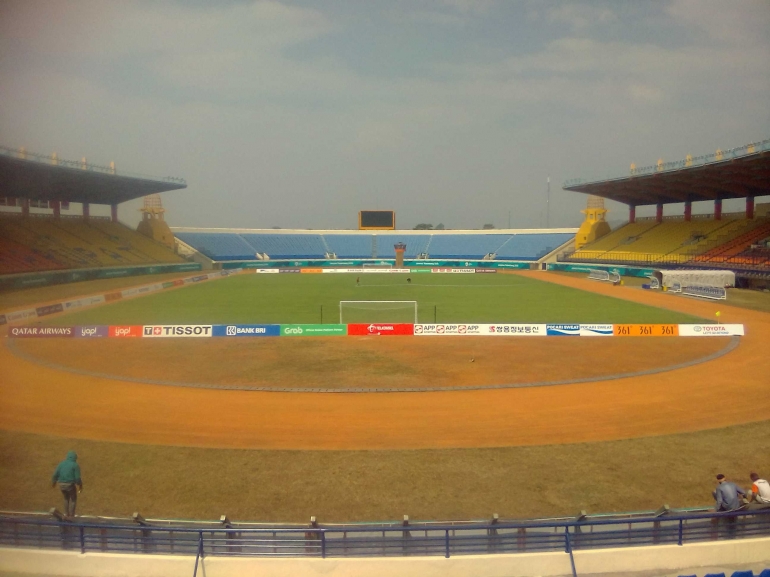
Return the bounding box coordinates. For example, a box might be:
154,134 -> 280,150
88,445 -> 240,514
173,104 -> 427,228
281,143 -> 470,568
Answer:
0,0 -> 770,229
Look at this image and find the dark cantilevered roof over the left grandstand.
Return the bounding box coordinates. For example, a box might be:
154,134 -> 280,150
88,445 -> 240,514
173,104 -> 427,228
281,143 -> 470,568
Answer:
0,147 -> 187,204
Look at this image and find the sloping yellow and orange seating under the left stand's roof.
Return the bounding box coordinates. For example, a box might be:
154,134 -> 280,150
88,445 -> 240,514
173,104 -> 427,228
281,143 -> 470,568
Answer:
0,215 -> 184,274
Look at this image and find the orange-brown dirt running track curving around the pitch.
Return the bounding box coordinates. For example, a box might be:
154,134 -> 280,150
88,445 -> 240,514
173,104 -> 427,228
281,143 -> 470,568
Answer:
0,273 -> 770,450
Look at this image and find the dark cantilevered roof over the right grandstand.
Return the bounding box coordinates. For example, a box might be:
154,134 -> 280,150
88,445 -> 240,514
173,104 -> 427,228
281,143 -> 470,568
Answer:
563,139 -> 770,206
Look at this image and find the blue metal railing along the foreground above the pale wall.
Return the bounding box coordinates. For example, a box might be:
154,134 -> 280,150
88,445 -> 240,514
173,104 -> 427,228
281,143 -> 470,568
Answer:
0,508 -> 770,558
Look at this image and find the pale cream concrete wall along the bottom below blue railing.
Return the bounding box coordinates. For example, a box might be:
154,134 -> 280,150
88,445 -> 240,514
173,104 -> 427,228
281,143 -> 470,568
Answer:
0,539 -> 770,577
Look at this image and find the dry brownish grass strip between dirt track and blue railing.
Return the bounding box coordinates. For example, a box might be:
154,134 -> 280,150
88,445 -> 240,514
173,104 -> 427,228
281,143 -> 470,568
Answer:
0,421 -> 770,522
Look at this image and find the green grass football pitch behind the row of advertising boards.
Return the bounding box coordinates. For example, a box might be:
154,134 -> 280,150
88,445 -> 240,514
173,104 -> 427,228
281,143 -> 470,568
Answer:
42,274 -> 702,325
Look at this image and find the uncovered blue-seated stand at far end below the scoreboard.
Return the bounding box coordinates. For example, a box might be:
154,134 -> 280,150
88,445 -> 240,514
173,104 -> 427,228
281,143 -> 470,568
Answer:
172,228 -> 575,261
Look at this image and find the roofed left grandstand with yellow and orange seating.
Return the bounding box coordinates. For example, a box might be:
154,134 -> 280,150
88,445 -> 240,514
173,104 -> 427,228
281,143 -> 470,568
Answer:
0,147 -> 186,274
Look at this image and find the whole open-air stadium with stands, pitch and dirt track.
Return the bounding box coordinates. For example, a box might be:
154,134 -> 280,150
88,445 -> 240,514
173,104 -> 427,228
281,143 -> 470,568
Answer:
0,135 -> 770,575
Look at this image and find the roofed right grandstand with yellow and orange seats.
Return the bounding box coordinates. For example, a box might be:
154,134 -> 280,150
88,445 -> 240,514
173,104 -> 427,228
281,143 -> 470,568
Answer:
560,140 -> 770,273
